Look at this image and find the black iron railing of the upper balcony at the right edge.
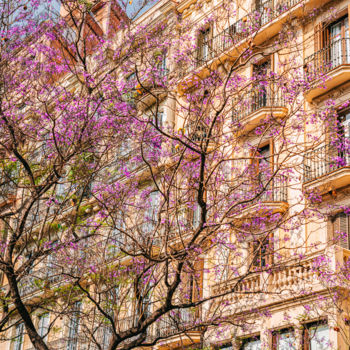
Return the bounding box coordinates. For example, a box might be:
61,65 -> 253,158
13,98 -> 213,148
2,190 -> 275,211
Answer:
304,38 -> 350,80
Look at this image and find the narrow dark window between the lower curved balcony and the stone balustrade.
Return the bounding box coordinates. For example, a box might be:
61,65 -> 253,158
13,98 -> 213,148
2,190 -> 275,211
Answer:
249,234 -> 274,270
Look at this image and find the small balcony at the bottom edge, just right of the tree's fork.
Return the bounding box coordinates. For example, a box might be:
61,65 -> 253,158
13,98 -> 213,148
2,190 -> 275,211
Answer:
154,310 -> 202,349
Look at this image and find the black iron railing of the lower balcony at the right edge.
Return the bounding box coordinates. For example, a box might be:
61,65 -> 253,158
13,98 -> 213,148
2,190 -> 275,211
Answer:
304,144 -> 350,182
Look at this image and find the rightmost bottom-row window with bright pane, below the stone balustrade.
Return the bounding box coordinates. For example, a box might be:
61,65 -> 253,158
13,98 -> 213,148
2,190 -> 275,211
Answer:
303,321 -> 330,350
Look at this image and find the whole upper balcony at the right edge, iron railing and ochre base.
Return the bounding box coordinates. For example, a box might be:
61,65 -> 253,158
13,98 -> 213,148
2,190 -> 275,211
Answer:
304,38 -> 350,102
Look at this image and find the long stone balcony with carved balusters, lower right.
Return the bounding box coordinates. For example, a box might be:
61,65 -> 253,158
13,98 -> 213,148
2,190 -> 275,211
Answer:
211,246 -> 350,309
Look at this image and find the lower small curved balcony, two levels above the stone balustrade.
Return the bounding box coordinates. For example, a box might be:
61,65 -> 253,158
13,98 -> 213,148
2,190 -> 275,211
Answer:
235,174 -> 288,223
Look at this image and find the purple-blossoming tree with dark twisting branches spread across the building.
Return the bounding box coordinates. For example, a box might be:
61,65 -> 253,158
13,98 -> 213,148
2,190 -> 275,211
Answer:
0,0 -> 348,350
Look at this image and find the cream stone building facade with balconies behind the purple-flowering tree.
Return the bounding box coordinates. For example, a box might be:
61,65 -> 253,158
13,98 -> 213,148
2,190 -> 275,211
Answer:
0,0 -> 350,350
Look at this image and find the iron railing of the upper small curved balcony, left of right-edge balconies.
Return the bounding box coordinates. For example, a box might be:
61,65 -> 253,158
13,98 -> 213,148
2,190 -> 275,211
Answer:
232,86 -> 286,122
